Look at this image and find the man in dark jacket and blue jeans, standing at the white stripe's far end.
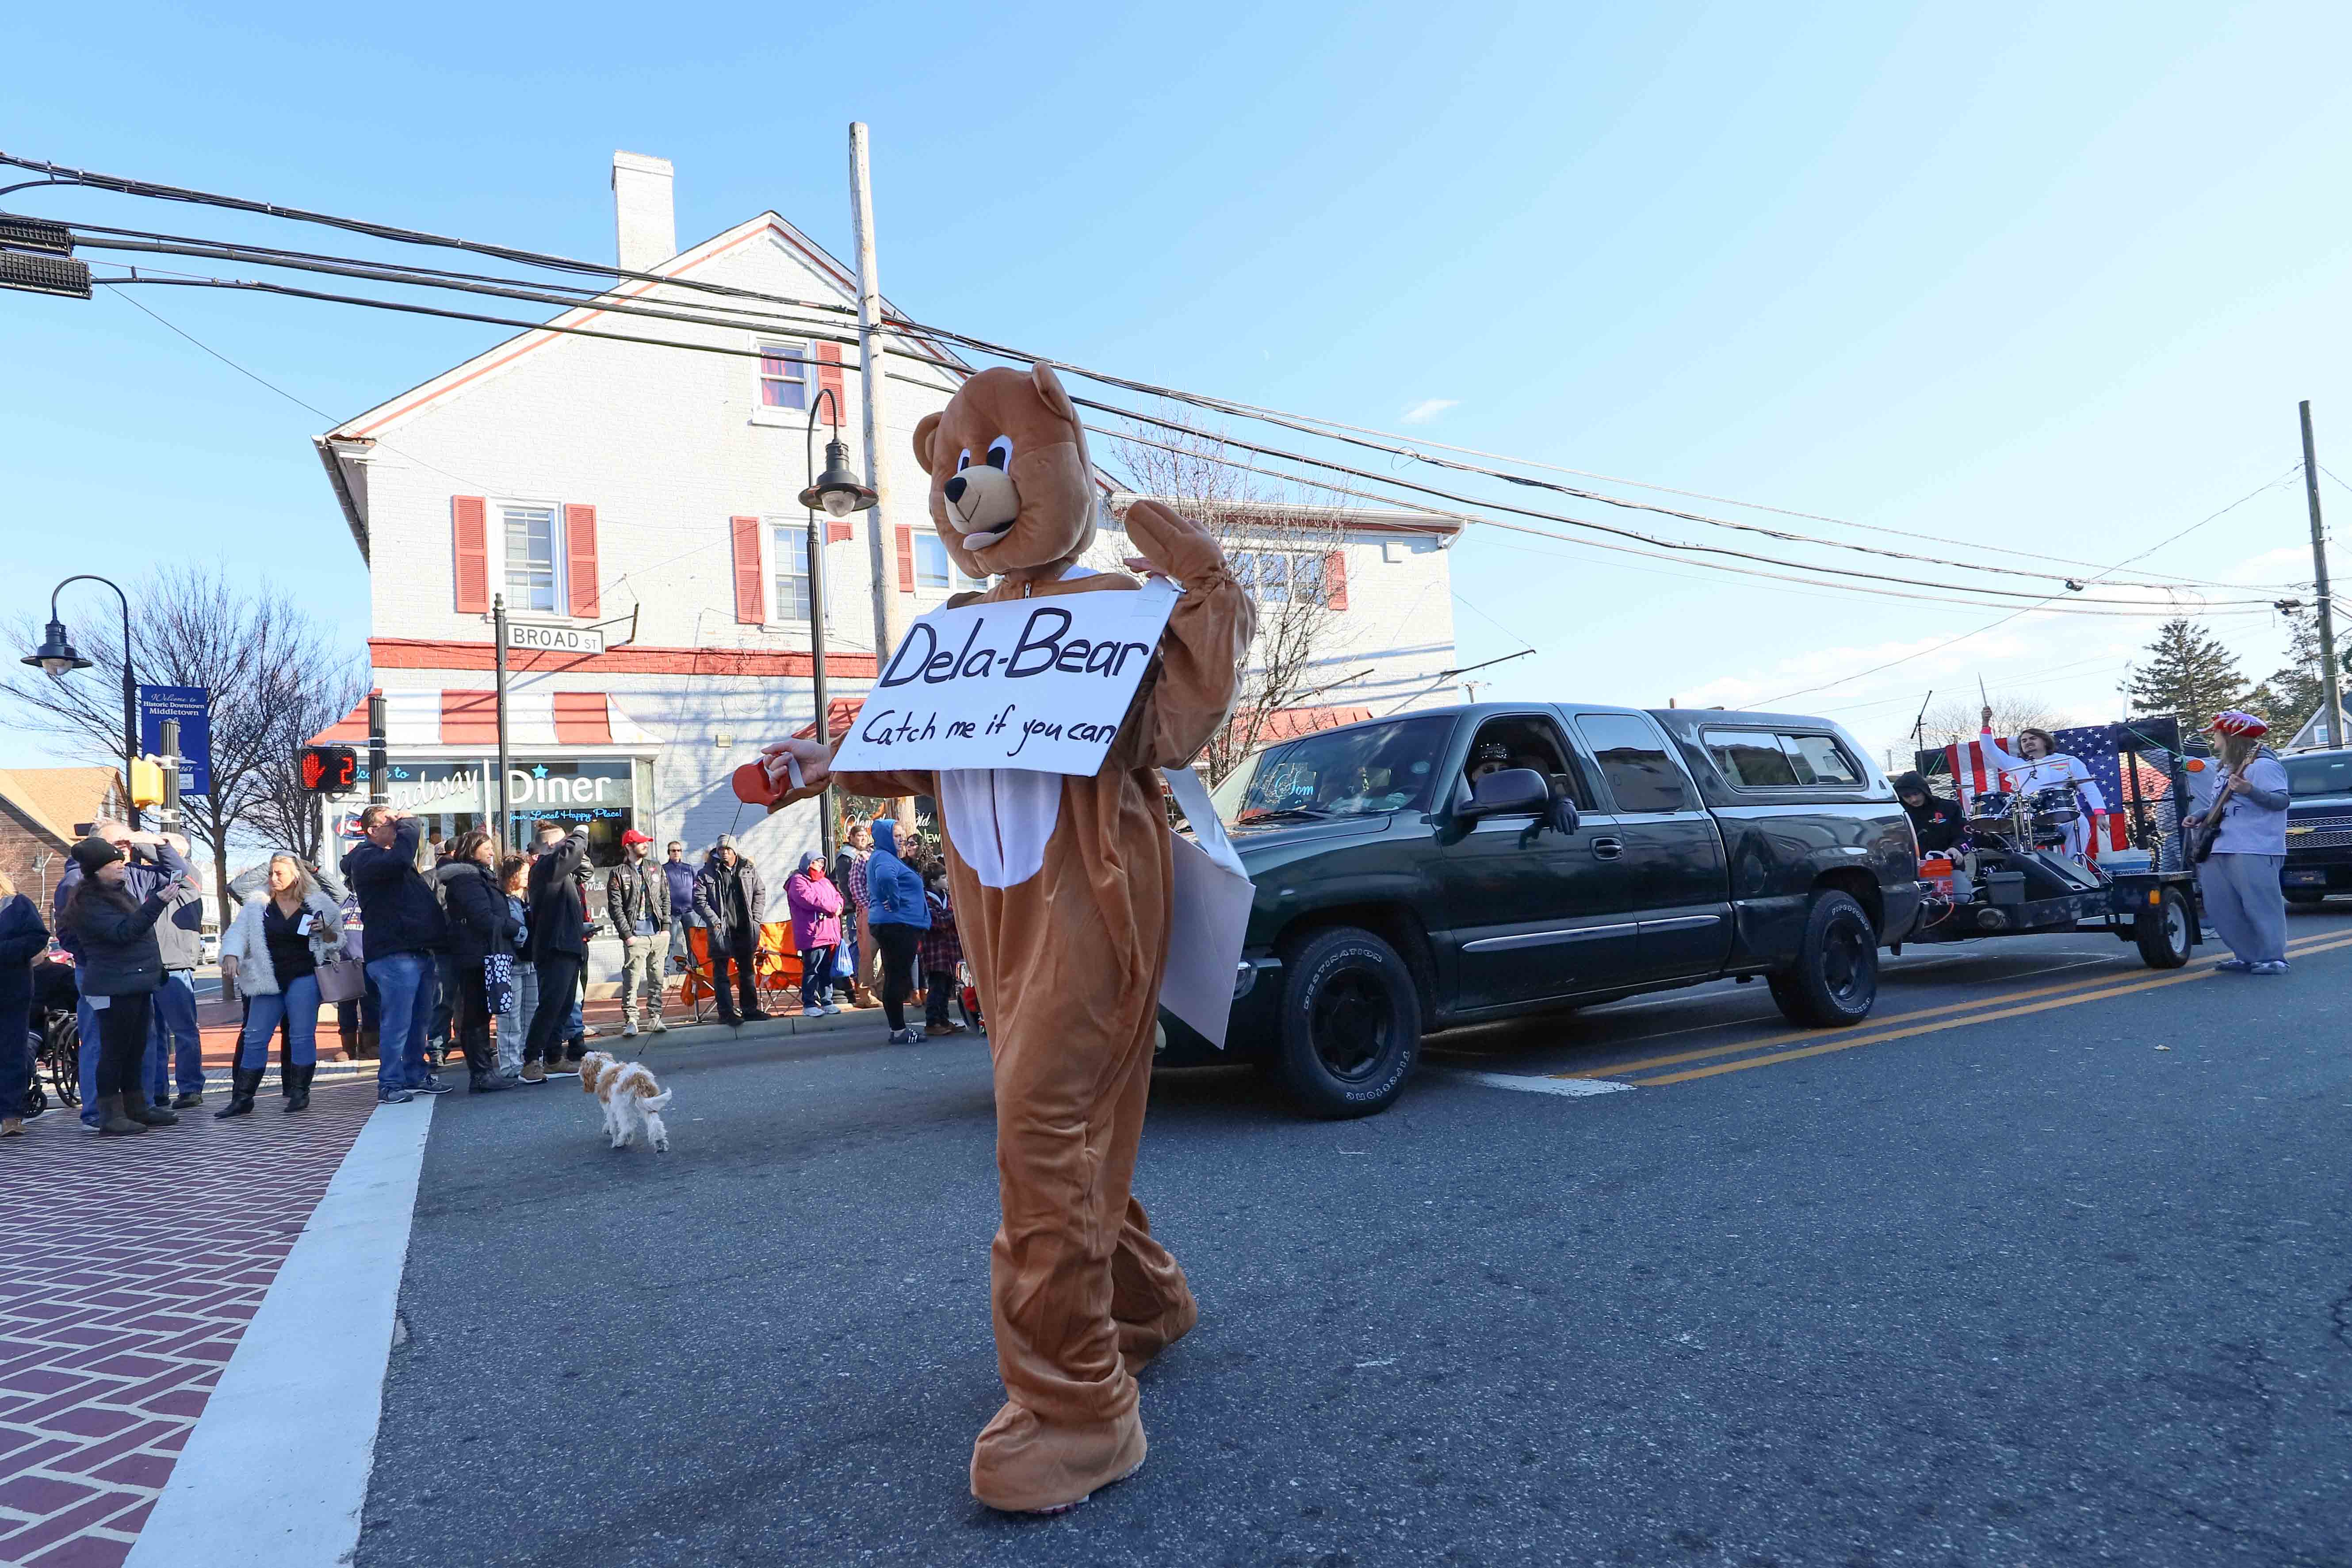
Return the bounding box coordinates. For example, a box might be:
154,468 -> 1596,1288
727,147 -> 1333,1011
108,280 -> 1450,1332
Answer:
344,807 -> 449,1105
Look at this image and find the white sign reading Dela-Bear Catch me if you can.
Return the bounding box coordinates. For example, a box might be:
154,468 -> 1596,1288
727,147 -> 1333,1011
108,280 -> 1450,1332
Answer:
833,581 -> 1176,773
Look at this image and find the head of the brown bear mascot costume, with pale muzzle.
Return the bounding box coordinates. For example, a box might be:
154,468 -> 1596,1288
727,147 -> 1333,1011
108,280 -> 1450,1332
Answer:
915,364 -> 1096,581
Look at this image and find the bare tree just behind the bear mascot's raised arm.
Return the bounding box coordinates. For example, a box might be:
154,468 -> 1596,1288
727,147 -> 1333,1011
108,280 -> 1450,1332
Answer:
1098,416 -> 1369,785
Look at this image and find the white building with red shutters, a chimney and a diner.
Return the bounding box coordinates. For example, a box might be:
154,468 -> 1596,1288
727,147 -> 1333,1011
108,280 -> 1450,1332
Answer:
317,153 -> 1458,907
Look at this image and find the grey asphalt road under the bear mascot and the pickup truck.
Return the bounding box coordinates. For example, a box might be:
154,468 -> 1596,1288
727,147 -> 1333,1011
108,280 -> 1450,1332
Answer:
352,910 -> 2352,1568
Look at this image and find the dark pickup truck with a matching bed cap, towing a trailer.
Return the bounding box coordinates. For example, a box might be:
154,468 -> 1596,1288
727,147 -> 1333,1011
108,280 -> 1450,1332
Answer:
1157,703 -> 1922,1117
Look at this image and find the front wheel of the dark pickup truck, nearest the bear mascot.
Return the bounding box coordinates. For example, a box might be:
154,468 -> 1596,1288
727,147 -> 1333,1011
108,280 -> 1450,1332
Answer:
1275,926 -> 1421,1119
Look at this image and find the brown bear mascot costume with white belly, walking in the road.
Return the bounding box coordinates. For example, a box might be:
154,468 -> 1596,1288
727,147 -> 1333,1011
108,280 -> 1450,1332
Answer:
767,364 -> 1256,1511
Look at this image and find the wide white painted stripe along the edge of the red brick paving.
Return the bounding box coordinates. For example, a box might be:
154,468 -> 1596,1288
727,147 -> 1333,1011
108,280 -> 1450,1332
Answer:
127,1098 -> 433,1568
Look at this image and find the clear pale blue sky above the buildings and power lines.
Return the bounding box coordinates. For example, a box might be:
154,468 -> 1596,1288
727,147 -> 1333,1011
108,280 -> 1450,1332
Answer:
0,5 -> 2352,764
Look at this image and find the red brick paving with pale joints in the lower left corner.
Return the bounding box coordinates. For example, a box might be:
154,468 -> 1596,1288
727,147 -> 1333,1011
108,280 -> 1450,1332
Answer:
0,1086 -> 374,1568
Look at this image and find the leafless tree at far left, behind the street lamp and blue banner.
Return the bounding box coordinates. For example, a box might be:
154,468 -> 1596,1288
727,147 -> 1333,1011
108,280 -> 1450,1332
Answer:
0,564 -> 360,917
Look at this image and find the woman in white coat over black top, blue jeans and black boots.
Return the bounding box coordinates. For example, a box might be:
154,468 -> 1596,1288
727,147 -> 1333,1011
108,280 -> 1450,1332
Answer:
214,856 -> 344,1121
